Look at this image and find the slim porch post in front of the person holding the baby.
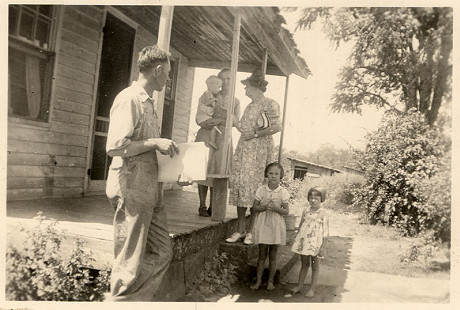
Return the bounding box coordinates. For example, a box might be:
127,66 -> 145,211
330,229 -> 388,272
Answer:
211,12 -> 241,222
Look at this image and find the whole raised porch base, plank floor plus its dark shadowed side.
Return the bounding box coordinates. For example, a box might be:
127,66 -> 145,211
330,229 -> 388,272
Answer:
6,190 -> 296,301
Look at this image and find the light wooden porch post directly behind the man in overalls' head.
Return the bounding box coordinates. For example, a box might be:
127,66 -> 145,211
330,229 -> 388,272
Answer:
154,5 -> 174,130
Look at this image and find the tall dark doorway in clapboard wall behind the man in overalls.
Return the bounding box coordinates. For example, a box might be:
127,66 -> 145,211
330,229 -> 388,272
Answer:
89,13 -> 136,186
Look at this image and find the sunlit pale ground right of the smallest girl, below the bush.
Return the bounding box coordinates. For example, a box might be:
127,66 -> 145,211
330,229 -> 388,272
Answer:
290,200 -> 450,279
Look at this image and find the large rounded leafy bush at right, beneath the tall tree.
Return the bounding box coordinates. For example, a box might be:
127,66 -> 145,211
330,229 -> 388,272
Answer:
355,111 -> 450,237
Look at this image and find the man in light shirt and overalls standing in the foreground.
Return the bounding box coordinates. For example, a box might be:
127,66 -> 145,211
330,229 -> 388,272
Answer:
106,46 -> 179,301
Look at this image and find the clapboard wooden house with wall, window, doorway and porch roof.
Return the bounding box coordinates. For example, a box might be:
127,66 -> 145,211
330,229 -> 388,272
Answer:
7,4 -> 310,206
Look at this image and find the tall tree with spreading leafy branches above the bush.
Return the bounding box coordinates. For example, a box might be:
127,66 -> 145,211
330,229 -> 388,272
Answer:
297,7 -> 453,125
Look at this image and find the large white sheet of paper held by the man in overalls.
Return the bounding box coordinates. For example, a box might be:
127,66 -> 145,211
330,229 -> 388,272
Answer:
157,142 -> 208,183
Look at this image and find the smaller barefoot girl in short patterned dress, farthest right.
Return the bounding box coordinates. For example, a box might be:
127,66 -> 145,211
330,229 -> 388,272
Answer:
292,187 -> 329,297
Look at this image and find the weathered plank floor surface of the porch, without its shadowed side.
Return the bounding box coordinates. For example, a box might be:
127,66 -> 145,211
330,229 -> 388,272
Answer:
6,190 -> 237,268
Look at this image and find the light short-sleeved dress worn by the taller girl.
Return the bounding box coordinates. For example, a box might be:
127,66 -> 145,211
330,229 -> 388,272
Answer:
252,185 -> 289,245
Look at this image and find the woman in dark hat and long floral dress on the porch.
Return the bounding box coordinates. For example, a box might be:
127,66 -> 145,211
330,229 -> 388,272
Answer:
226,72 -> 281,244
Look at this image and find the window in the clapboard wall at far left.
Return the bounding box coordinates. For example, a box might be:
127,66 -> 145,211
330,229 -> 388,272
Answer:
8,5 -> 55,121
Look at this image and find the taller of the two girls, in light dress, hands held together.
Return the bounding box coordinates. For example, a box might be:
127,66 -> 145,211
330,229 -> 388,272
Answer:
251,162 -> 289,291
